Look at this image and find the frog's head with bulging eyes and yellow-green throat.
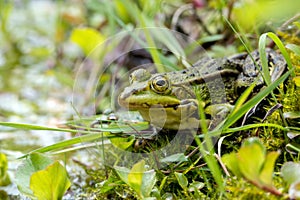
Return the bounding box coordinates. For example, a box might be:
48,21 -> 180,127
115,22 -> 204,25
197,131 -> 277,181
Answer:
118,69 -> 199,129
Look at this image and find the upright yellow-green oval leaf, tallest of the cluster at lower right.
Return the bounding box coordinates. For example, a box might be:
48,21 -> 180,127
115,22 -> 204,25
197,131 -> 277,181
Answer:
237,138 -> 266,183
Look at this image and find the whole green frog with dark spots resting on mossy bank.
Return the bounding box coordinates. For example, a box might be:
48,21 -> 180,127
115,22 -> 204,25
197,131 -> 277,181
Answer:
118,49 -> 286,130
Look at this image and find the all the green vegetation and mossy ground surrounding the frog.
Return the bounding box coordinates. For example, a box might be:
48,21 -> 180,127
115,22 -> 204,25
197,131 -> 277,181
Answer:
0,0 -> 300,199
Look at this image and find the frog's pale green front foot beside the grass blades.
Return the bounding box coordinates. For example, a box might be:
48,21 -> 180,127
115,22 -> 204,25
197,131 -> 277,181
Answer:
205,103 -> 233,130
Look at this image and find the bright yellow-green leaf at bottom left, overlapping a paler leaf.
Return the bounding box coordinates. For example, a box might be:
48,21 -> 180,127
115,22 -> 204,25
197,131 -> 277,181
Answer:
30,161 -> 71,200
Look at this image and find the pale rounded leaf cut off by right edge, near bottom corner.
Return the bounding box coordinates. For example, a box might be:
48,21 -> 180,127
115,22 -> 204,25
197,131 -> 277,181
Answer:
281,162 -> 300,185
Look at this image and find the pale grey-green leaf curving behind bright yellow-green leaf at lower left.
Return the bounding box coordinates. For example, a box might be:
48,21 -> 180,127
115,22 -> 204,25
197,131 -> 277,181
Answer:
15,153 -> 53,198
